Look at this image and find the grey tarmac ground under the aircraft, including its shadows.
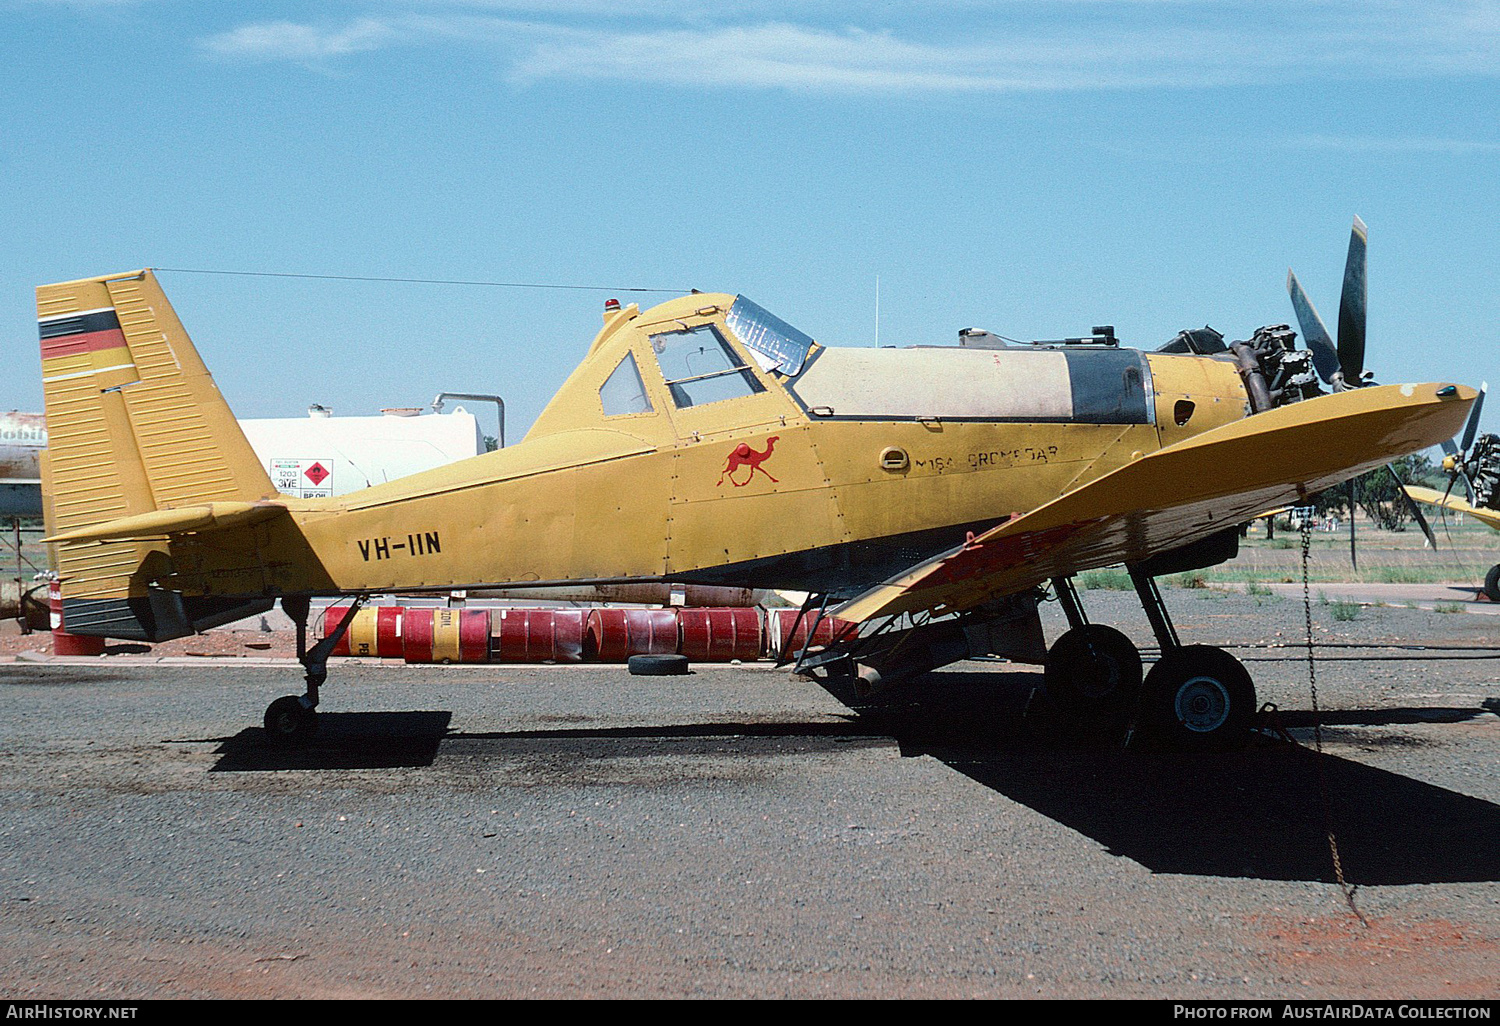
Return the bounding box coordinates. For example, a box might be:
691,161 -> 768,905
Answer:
0,591 -> 1500,999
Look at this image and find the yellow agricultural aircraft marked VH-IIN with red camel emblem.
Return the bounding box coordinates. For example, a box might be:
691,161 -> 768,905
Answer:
38,222 -> 1476,747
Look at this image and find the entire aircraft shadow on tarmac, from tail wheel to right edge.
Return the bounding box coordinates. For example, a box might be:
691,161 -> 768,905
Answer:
202,672 -> 1500,885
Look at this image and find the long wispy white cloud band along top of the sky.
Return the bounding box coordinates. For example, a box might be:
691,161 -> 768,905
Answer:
203,0 -> 1500,95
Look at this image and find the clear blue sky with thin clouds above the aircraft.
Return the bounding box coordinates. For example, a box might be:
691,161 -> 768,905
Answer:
0,0 -> 1500,438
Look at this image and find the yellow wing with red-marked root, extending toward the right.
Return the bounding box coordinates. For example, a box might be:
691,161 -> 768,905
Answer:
831,384 -> 1478,621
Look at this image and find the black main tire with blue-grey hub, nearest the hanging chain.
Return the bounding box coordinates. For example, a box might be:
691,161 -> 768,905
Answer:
1142,645 -> 1256,752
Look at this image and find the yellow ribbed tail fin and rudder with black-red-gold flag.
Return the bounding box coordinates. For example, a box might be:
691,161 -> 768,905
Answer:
36,270 -> 276,641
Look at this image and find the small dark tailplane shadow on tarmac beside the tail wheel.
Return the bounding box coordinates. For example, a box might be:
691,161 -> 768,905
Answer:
210,713 -> 453,773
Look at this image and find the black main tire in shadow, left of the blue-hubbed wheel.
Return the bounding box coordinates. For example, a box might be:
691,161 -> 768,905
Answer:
1044,624 -> 1142,723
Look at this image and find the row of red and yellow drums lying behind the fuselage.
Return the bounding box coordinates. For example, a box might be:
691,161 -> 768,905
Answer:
323,606 -> 854,663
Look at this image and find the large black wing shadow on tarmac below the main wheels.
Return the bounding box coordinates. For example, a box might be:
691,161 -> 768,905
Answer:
867,674 -> 1500,885
